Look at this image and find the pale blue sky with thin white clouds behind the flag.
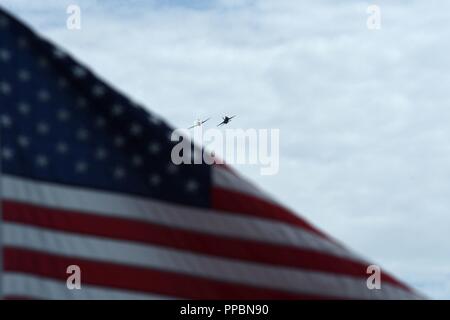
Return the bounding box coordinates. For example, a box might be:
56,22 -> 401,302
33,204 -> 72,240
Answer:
0,0 -> 450,299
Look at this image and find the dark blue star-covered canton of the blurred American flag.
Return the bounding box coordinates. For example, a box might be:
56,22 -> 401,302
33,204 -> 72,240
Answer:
0,9 -> 210,206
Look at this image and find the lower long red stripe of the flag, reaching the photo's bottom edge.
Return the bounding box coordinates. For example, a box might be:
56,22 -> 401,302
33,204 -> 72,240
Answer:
4,247 -> 330,299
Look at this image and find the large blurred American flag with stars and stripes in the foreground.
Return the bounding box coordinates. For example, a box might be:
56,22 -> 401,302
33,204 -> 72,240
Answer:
0,10 -> 420,299
